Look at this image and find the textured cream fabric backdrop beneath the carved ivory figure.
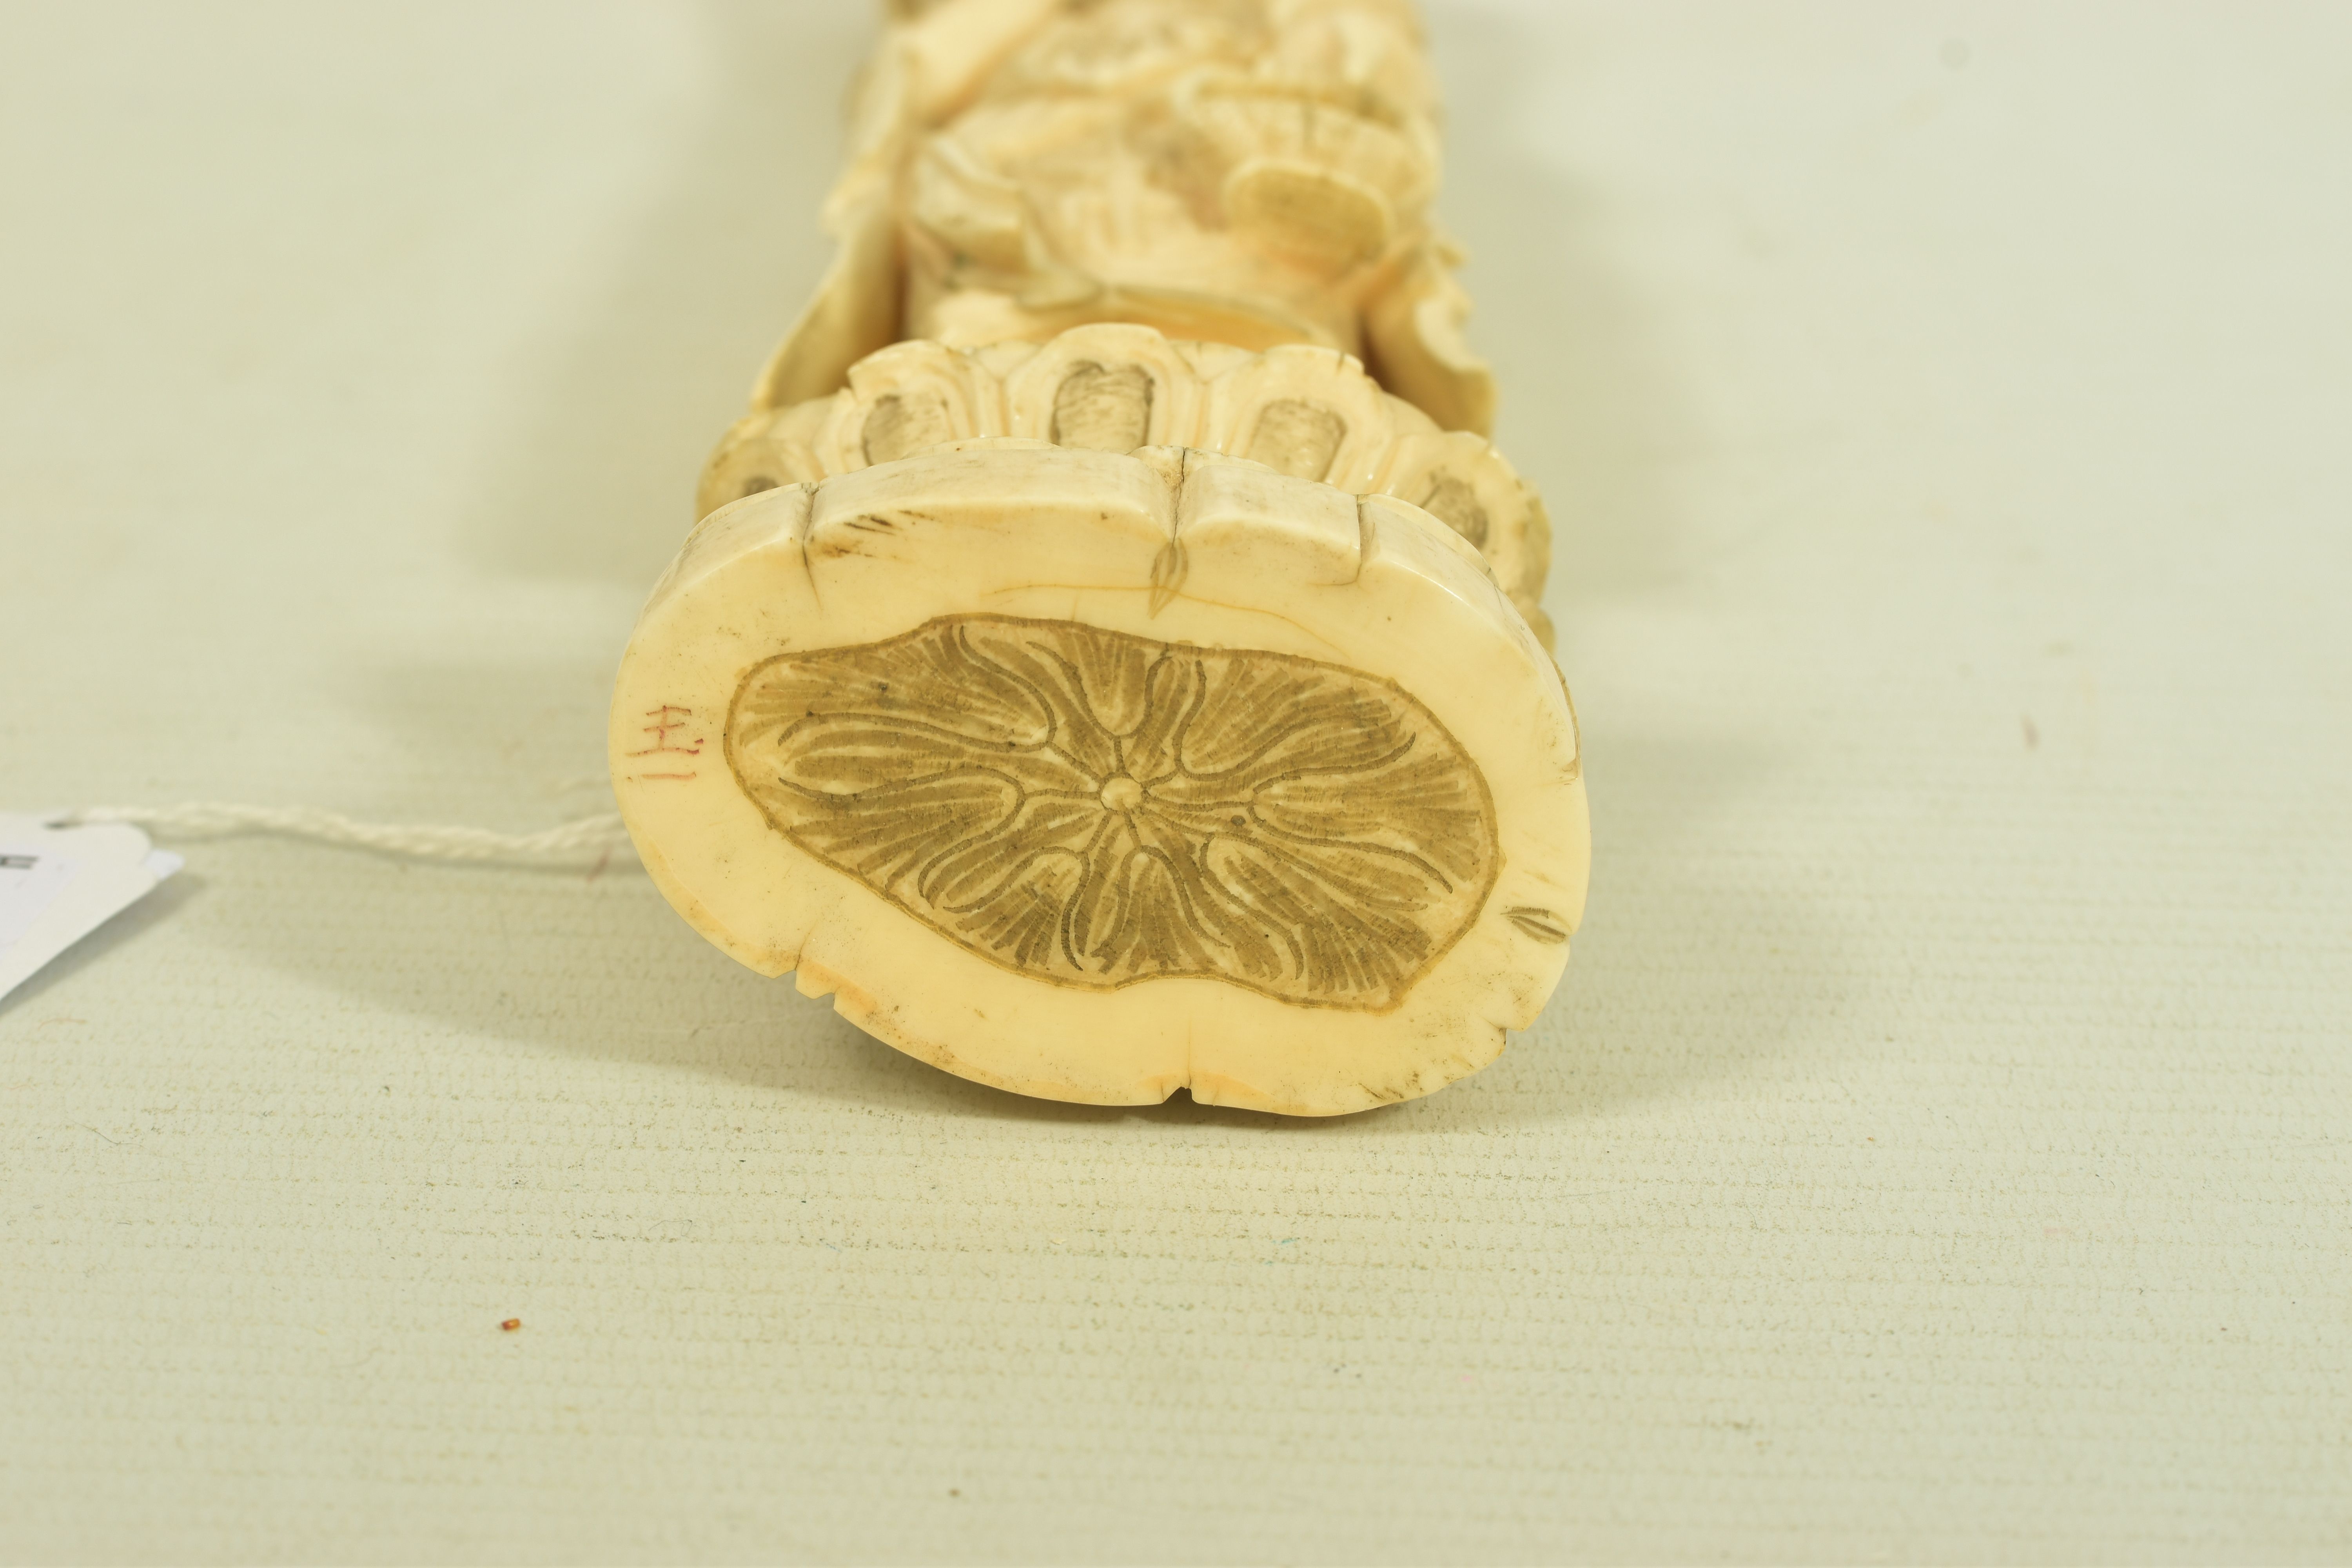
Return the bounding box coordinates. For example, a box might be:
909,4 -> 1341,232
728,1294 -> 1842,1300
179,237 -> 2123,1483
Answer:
0,0 -> 2352,1563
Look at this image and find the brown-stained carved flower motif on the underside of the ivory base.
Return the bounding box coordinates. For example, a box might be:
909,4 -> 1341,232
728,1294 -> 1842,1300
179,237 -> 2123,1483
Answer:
727,616 -> 1498,1011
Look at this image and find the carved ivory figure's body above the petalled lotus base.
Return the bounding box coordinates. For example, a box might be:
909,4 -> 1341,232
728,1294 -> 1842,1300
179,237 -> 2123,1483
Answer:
760,0 -> 1494,432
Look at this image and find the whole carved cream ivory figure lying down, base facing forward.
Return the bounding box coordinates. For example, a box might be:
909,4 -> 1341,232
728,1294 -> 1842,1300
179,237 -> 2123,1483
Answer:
612,0 -> 1590,1114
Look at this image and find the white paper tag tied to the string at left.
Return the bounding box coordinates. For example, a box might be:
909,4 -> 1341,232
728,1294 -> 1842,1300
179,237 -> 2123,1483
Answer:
0,816 -> 183,997
